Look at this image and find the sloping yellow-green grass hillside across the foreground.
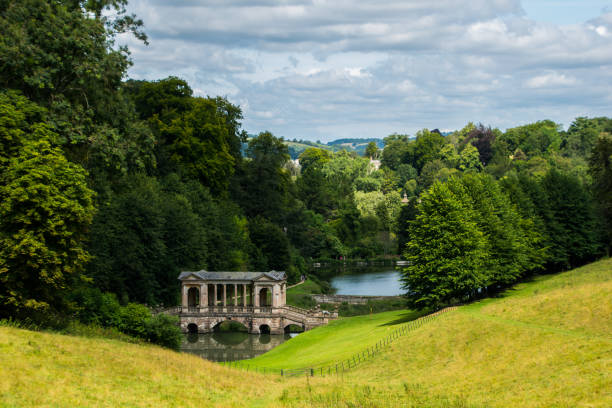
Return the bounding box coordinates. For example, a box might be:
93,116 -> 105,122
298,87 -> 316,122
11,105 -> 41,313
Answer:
0,259 -> 612,408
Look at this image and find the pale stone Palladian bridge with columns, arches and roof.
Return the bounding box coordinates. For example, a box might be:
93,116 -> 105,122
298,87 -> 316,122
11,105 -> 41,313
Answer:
176,270 -> 338,334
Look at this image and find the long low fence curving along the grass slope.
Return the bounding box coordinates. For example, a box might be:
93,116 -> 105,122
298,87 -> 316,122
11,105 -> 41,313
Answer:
220,306 -> 457,377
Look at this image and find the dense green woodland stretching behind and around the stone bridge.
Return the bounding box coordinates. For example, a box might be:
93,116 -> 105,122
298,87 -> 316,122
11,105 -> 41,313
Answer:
0,0 -> 612,341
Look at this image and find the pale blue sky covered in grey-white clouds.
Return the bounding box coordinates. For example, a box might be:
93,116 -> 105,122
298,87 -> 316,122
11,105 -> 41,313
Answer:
118,0 -> 612,142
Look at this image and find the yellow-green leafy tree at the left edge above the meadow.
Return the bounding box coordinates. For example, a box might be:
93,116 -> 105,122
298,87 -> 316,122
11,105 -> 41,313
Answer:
0,94 -> 94,317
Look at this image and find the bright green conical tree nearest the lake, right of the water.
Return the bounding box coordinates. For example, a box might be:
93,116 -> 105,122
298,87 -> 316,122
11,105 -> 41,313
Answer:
402,179 -> 487,309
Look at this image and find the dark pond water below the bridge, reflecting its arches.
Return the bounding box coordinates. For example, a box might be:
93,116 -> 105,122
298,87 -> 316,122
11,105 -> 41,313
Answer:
181,332 -> 297,361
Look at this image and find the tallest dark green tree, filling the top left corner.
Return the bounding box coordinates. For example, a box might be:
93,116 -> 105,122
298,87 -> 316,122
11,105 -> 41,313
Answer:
0,0 -> 148,174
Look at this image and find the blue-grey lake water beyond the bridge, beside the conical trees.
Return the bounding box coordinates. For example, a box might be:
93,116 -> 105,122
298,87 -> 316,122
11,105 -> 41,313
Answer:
331,267 -> 405,296
